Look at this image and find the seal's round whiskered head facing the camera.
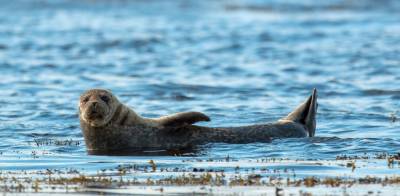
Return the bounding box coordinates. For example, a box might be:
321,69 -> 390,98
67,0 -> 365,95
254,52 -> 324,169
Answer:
79,89 -> 120,127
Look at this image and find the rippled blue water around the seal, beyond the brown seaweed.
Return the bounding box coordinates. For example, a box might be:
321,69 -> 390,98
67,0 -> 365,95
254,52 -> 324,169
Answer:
0,0 -> 400,194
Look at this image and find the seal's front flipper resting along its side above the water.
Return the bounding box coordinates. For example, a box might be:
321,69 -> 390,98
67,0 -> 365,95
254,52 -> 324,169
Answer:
157,112 -> 210,127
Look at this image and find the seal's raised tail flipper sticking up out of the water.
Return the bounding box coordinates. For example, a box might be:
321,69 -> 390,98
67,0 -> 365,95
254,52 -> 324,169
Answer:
283,88 -> 318,137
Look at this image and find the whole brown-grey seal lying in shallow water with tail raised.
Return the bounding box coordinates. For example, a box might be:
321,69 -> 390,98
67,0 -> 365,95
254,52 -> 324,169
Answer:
79,89 -> 318,155
